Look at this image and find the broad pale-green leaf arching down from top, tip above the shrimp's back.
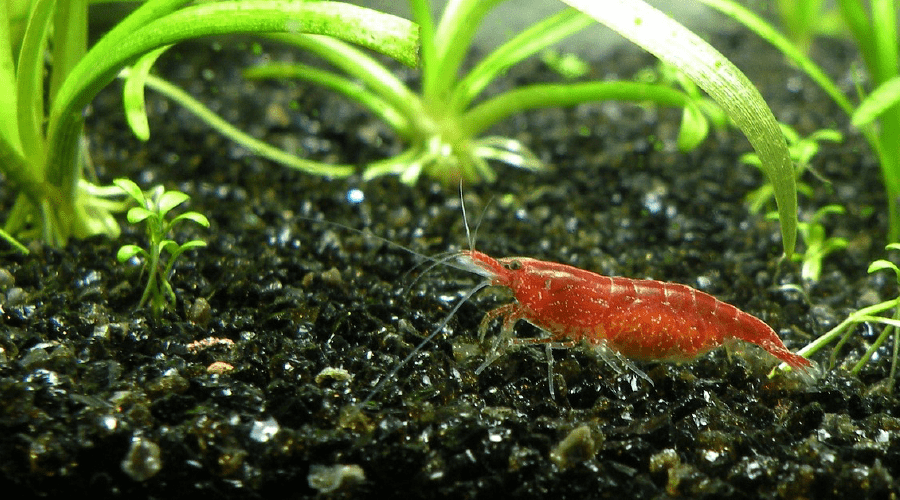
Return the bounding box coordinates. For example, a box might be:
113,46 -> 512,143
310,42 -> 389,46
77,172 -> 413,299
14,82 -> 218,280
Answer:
563,0 -> 797,255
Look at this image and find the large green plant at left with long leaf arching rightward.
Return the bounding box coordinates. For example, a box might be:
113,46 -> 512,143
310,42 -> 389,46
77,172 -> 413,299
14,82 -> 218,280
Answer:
0,0 -> 418,245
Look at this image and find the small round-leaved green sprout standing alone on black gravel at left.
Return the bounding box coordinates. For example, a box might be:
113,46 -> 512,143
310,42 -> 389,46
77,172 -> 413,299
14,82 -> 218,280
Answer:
113,179 -> 209,317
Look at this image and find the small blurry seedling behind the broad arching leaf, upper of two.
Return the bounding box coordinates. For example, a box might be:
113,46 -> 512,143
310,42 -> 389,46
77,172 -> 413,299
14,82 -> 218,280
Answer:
740,123 -> 844,213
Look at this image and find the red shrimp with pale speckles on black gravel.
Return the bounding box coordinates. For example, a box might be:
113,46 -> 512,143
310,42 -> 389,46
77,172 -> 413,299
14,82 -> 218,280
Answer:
456,250 -> 811,394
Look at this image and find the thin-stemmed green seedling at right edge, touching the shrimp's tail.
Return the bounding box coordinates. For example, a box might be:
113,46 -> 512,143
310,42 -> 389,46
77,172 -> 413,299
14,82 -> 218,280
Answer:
769,243 -> 900,390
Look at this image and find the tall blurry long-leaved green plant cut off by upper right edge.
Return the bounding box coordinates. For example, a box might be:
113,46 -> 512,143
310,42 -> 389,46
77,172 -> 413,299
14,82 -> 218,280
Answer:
700,0 -> 900,241
